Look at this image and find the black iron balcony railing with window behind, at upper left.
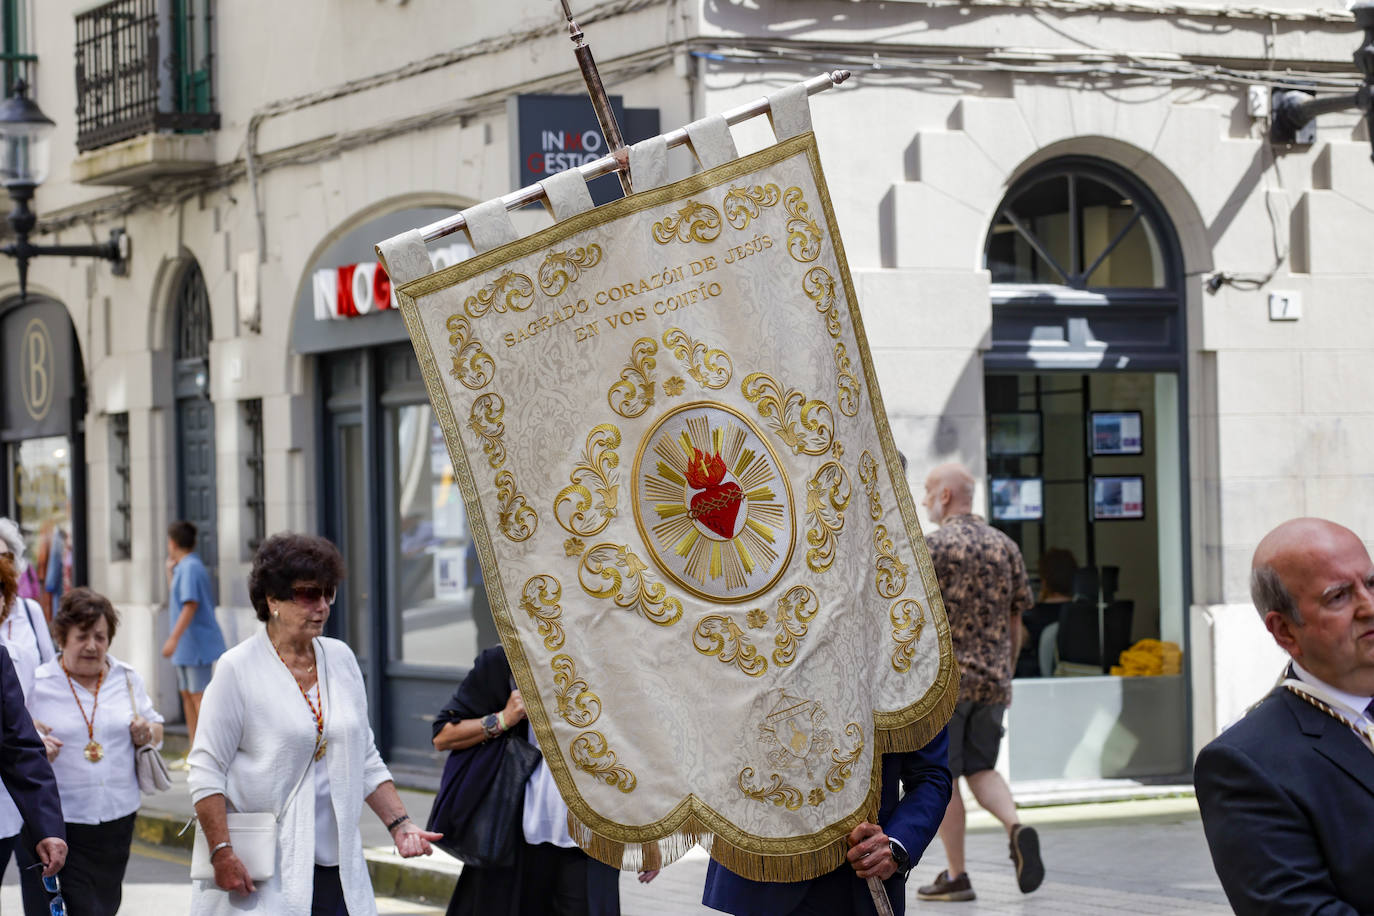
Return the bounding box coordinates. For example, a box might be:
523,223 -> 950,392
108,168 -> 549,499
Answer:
76,0 -> 220,152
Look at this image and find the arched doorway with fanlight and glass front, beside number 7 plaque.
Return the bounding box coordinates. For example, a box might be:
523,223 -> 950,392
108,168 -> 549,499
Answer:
984,157 -> 1190,780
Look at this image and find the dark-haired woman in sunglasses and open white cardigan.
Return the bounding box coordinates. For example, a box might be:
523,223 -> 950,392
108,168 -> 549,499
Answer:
190,534 -> 440,916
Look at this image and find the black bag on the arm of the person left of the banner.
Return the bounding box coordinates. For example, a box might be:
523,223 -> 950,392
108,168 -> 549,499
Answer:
427,733 -> 541,868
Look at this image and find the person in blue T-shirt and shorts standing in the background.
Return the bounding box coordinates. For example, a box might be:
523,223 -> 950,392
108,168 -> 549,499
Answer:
162,522 -> 224,744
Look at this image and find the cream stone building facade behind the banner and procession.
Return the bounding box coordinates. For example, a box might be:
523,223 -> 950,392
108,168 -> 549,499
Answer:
0,0 -> 1374,781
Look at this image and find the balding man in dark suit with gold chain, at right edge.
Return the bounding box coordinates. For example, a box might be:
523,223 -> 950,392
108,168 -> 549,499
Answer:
1194,519 -> 1374,916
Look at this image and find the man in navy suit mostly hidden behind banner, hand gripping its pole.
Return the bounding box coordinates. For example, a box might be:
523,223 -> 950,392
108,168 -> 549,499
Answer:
701,729 -> 951,916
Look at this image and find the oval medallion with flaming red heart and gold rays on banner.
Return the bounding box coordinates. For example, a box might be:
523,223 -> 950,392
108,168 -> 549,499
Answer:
633,401 -> 796,603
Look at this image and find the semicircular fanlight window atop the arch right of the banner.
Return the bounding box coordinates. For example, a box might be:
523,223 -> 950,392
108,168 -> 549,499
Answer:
985,162 -> 1171,290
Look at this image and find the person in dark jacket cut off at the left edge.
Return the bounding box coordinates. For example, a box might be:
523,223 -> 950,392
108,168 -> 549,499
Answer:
0,645 -> 67,878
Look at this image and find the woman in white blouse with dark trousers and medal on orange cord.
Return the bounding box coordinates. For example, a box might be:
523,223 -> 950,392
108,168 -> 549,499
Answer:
29,588 -> 162,916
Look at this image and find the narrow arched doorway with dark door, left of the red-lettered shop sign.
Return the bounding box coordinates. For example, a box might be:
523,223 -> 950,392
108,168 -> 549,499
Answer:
172,261 -> 218,591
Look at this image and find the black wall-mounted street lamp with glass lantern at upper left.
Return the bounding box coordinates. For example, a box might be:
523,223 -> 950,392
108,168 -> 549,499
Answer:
0,79 -> 128,302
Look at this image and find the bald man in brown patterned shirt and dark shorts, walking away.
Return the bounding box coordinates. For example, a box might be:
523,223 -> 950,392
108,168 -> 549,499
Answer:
916,464 -> 1044,900
